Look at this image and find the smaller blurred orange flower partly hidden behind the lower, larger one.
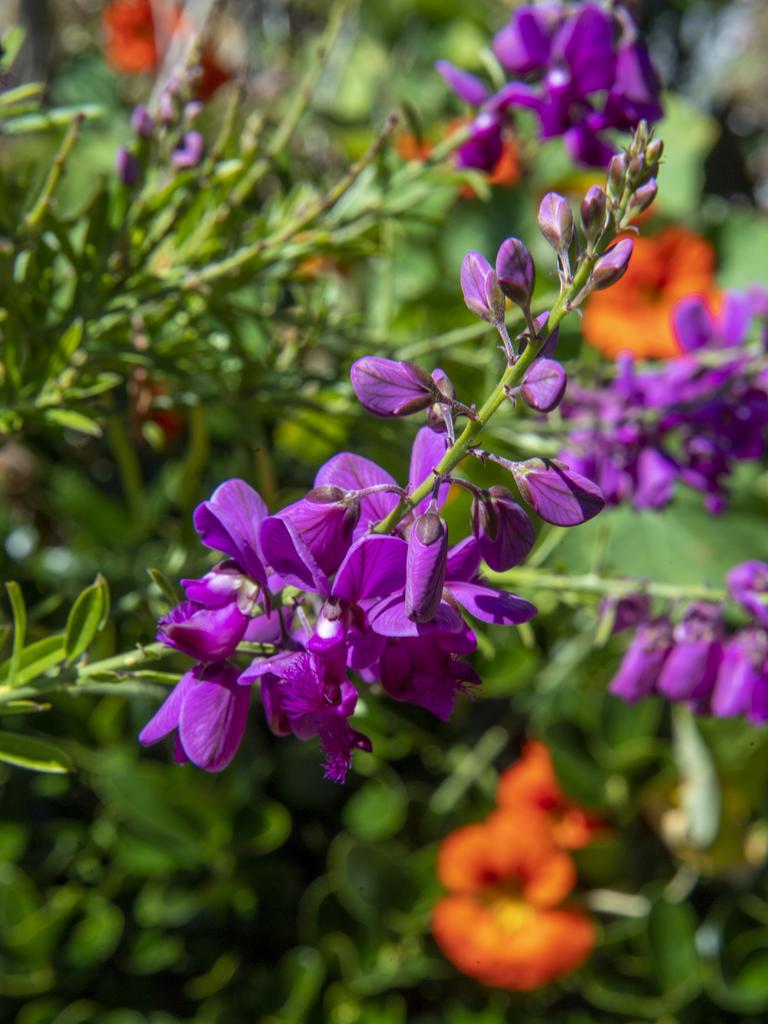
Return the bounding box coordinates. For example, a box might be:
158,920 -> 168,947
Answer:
496,740 -> 605,850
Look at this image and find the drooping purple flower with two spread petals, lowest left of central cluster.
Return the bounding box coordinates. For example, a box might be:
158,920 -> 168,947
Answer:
138,664 -> 251,771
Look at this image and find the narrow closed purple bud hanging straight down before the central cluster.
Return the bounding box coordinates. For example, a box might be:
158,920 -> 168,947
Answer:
406,501 -> 447,623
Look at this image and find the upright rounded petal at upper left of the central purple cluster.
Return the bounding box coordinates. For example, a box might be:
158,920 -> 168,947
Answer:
193,480 -> 268,585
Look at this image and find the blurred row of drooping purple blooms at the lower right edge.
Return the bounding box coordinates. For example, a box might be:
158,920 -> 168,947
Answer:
609,562 -> 768,725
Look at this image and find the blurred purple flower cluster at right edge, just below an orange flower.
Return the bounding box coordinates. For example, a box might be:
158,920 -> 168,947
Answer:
561,288 -> 768,514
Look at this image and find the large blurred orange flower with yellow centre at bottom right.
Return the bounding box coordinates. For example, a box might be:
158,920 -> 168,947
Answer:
432,813 -> 595,990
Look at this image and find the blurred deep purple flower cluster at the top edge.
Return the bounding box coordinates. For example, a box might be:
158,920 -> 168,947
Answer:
437,2 -> 662,171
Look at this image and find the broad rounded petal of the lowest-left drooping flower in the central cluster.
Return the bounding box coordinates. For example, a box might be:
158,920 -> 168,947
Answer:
179,666 -> 251,771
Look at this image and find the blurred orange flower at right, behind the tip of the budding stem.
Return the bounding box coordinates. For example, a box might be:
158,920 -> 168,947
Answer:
582,227 -> 720,359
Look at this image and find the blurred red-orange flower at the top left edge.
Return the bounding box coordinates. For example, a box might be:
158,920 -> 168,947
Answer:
101,0 -> 229,96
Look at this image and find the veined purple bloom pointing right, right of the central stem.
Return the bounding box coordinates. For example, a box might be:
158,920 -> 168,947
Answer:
510,459 -> 605,526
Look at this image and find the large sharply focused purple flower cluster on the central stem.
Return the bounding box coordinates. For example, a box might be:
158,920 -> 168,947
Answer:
139,339 -> 603,781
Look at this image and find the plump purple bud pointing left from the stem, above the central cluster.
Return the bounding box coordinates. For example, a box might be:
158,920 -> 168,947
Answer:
349,355 -> 437,416
